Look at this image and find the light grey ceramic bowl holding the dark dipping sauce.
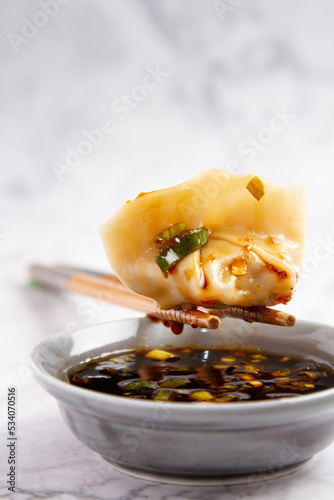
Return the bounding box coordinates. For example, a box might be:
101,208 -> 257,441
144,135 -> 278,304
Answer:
31,318 -> 334,484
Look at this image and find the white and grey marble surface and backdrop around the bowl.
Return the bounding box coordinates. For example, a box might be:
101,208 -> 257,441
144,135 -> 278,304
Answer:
0,0 -> 334,500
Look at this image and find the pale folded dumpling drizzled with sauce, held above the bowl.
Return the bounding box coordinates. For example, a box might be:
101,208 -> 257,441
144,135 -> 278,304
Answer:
99,170 -> 305,309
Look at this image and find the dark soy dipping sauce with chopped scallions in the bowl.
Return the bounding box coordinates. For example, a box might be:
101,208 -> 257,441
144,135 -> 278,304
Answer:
68,348 -> 334,403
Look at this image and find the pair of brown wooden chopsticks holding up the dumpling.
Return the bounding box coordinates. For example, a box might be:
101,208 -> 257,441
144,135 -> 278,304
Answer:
30,265 -> 296,329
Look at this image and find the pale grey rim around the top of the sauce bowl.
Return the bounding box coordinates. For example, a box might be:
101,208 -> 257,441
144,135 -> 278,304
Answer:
29,317 -> 334,418
